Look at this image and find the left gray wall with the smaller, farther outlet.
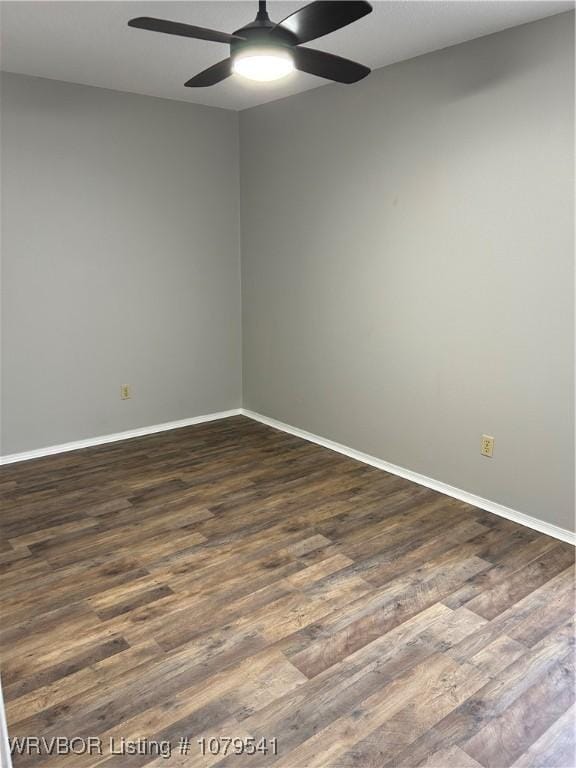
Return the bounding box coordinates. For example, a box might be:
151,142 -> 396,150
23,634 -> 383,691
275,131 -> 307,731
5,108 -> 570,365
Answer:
1,74 -> 242,454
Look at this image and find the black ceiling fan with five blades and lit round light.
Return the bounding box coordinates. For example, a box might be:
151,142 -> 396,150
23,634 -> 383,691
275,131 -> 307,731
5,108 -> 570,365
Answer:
128,0 -> 372,88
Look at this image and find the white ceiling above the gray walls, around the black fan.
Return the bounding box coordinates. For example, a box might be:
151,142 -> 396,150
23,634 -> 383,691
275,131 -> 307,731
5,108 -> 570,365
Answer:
1,0 -> 574,110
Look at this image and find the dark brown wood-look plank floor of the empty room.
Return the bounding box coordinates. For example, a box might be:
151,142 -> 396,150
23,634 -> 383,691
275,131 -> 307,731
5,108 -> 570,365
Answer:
0,417 -> 576,768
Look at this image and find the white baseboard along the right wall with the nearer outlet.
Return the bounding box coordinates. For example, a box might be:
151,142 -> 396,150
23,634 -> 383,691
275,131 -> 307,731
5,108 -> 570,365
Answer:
242,409 -> 576,545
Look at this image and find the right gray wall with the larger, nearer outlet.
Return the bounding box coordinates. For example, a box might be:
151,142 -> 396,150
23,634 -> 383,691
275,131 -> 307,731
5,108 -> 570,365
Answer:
240,14 -> 574,528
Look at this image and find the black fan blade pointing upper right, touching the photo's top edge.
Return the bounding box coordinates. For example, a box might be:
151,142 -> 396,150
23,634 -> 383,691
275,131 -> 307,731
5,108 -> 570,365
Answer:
276,0 -> 372,43
